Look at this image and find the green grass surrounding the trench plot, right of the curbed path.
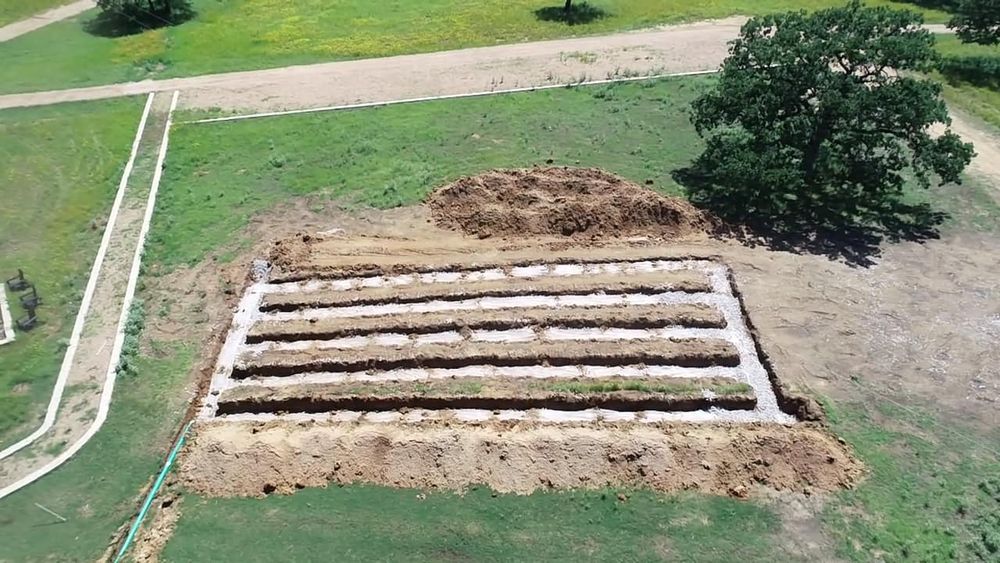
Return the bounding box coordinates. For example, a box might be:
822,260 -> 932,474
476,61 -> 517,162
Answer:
0,79 -> 1000,561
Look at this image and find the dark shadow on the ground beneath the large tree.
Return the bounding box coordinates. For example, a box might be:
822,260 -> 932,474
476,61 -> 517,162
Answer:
672,167 -> 948,267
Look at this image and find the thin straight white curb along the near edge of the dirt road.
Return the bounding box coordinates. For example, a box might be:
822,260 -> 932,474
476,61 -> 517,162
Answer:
181,69 -> 719,125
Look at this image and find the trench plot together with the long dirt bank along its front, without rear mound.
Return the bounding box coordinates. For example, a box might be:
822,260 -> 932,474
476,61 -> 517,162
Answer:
181,253 -> 852,495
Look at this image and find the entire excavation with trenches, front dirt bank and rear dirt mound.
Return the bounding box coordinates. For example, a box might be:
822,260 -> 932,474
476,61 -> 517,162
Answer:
180,168 -> 862,496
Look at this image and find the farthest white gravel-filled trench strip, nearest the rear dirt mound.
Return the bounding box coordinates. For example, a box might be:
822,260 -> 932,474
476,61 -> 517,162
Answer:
262,258 -> 715,294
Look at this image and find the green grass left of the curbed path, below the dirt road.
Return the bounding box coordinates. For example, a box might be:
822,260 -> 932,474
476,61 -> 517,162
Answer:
0,99 -> 142,445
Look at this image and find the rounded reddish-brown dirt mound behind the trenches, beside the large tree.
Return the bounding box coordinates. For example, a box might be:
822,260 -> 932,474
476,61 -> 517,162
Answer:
427,168 -> 716,238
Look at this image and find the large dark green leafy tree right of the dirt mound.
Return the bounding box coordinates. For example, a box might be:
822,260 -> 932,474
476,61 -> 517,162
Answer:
680,1 -> 973,240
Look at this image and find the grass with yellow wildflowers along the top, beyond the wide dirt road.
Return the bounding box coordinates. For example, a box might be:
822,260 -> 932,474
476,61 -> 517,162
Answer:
0,0 -> 945,93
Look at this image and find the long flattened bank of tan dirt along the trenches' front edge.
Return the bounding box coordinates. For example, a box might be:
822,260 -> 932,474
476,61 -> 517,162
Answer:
180,422 -> 862,496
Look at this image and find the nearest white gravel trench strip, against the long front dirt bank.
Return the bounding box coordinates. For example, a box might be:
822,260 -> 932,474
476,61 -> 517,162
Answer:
213,408 -> 794,425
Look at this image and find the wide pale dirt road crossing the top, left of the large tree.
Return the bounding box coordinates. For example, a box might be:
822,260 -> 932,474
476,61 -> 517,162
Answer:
0,18 -> 744,110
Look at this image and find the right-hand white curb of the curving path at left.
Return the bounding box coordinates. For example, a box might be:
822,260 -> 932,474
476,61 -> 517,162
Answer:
0,91 -> 180,499
